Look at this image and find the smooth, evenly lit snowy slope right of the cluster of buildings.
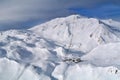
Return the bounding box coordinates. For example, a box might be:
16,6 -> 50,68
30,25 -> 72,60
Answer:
82,42 -> 120,68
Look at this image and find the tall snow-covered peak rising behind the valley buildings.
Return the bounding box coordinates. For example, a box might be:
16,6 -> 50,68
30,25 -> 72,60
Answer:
30,15 -> 120,53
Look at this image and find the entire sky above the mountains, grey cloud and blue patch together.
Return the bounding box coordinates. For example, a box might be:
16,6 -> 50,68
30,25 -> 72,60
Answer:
0,0 -> 120,30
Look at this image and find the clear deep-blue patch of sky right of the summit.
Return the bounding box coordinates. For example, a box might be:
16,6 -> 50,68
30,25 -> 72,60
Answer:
70,4 -> 120,21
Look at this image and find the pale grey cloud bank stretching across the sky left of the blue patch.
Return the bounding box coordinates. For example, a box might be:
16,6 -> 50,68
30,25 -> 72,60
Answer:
0,0 -> 117,30
